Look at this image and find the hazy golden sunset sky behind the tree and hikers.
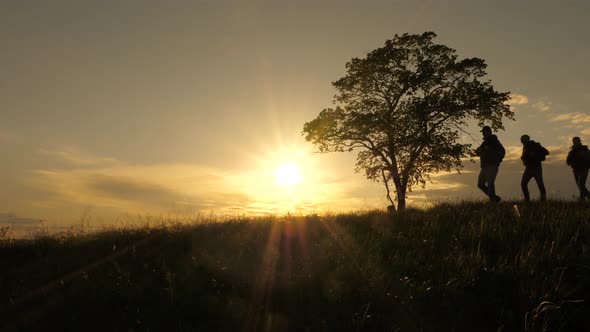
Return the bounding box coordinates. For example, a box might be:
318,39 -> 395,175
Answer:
0,0 -> 590,233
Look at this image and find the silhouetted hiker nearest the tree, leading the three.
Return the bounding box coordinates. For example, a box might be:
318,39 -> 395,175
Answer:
475,126 -> 506,202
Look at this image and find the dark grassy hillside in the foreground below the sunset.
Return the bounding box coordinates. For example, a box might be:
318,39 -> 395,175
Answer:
0,202 -> 590,331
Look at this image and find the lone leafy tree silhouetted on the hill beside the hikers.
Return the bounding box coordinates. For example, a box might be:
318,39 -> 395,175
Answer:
302,32 -> 514,209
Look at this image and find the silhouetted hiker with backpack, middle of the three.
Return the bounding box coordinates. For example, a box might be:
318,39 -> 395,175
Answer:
520,135 -> 549,202
